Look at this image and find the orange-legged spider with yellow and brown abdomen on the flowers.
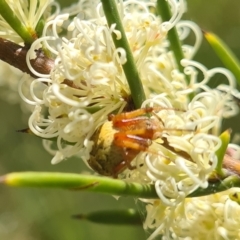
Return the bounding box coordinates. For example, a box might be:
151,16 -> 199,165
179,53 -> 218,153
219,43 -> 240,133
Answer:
88,107 -> 189,178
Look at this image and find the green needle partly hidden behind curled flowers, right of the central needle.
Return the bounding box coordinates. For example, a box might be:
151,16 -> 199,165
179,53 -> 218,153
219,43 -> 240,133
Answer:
157,0 -> 189,81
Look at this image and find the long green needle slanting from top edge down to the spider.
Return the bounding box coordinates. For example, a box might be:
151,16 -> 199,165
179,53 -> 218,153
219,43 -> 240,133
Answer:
101,0 -> 146,108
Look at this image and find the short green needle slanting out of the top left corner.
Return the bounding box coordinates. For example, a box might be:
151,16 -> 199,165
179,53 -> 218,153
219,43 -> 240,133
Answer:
0,0 -> 34,45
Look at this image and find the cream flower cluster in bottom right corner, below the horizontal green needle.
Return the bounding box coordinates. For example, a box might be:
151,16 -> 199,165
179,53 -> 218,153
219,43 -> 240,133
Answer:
144,188 -> 240,240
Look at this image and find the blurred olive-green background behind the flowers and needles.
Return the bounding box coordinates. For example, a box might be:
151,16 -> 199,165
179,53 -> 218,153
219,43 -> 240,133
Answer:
0,0 -> 240,240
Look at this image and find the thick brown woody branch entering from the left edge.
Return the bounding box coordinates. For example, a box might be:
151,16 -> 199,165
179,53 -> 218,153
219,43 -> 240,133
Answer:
0,38 -> 54,78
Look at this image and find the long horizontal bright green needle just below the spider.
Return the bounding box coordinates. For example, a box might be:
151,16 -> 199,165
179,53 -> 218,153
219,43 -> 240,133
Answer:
0,172 -> 158,199
